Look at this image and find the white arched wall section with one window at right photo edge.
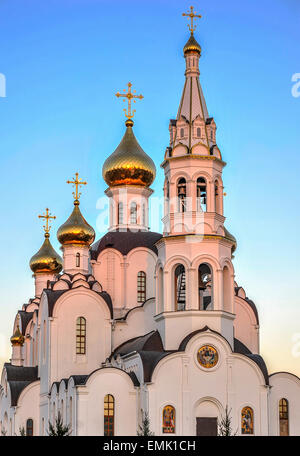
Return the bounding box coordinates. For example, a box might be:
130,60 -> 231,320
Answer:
270,372 -> 300,436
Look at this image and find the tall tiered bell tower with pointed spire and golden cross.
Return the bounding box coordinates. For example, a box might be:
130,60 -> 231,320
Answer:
156,7 -> 236,350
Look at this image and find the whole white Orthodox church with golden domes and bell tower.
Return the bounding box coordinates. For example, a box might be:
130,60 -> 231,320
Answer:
0,7 -> 300,437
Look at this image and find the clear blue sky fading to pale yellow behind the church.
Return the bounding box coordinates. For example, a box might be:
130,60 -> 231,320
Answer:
0,0 -> 300,375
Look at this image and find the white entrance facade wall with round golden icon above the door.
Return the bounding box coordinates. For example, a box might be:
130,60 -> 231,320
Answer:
148,332 -> 268,435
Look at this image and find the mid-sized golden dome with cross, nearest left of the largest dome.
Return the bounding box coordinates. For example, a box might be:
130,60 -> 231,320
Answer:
57,173 -> 95,246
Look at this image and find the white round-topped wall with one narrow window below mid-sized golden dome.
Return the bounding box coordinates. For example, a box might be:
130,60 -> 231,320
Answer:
50,288 -> 111,384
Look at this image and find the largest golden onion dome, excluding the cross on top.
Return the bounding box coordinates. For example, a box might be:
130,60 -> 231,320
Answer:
102,119 -> 156,187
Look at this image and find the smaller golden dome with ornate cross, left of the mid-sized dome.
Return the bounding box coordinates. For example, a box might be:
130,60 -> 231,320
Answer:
29,208 -> 62,274
